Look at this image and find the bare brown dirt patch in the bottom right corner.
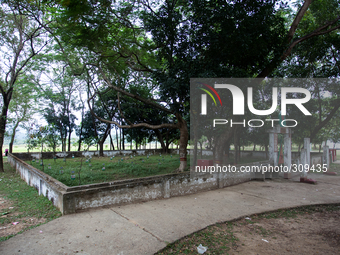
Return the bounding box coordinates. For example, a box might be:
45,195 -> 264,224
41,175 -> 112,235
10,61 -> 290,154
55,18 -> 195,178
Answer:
229,210 -> 340,255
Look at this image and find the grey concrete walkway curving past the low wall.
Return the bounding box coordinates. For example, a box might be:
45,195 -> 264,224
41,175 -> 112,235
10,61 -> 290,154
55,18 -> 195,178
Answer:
0,174 -> 340,255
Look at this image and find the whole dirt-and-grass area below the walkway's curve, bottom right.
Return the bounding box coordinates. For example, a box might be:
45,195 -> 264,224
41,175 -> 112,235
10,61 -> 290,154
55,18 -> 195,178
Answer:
157,205 -> 340,255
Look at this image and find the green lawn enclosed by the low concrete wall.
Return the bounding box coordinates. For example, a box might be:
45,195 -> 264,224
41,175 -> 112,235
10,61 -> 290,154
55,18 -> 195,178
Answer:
27,154 -> 190,186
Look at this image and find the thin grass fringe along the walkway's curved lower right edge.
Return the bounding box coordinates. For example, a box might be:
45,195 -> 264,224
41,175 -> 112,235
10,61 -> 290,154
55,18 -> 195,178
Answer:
156,204 -> 340,255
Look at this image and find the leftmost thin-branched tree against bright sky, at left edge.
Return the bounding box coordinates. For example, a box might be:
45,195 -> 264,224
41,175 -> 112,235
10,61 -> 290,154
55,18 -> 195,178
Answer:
0,3 -> 48,172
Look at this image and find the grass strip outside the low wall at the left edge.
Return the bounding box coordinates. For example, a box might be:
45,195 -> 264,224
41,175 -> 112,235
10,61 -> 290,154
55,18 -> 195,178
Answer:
0,160 -> 61,241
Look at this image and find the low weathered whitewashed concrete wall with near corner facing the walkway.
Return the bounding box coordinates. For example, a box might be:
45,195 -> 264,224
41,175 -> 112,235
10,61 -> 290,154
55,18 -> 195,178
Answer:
8,153 -> 268,214
